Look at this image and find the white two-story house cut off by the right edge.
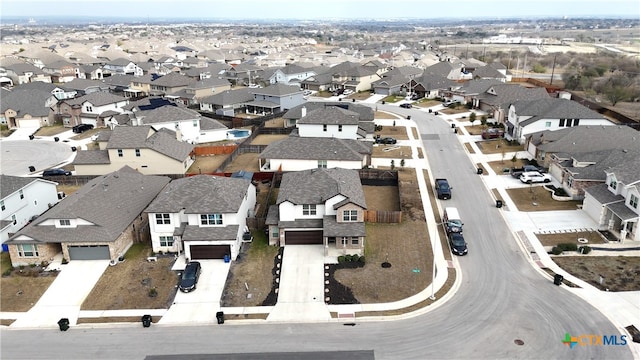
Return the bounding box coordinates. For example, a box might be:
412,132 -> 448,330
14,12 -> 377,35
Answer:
582,155 -> 640,243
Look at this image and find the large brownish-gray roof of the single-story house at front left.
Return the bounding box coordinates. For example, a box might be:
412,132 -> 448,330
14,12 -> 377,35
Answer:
10,166 -> 170,243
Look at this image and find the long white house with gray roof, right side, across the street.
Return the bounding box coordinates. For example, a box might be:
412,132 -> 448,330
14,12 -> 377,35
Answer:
506,98 -> 615,144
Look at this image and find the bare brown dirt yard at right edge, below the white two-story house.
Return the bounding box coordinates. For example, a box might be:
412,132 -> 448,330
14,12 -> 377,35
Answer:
553,255 -> 640,291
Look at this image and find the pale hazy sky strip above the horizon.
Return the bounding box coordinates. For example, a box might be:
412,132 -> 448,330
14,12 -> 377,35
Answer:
0,0 -> 640,20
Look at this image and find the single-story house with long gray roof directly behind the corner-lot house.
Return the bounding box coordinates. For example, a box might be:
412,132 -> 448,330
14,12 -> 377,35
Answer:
258,136 -> 373,171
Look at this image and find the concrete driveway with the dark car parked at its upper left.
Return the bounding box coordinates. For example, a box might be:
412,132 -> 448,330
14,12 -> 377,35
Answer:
158,260 -> 231,324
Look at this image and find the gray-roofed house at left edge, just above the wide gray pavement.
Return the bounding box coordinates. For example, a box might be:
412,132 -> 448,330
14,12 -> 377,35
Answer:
0,88 -> 57,129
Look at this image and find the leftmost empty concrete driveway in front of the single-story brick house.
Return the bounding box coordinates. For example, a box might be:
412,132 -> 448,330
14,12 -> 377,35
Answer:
11,260 -> 109,328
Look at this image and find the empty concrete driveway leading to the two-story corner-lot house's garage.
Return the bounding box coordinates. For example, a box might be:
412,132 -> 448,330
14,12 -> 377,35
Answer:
267,245 -> 331,322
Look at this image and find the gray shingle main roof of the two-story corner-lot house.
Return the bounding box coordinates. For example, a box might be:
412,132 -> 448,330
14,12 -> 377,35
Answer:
276,168 -> 367,209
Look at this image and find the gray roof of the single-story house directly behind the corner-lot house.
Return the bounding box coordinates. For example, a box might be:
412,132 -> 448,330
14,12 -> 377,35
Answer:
260,136 -> 373,161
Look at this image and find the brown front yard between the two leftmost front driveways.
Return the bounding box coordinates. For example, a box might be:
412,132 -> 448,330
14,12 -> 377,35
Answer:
81,244 -> 178,310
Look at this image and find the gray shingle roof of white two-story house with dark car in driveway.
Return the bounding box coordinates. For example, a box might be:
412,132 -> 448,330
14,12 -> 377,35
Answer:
145,175 -> 251,215
